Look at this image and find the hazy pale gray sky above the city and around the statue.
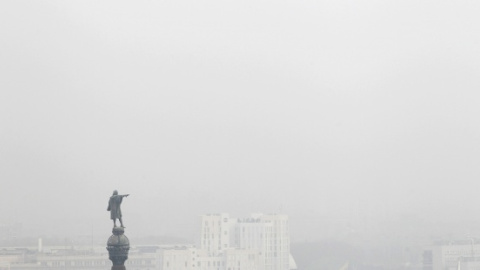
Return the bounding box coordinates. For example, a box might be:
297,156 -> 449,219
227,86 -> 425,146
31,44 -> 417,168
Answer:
0,0 -> 480,238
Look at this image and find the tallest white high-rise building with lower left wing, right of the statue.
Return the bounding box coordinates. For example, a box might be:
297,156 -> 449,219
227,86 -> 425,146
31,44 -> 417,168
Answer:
159,213 -> 296,270
